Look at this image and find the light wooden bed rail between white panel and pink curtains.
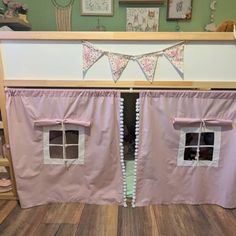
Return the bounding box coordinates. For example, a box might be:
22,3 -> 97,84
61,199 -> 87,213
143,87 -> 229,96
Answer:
4,80 -> 236,89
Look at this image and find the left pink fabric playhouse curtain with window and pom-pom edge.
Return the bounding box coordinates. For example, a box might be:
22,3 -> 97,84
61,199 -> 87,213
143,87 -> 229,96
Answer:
6,89 -> 125,208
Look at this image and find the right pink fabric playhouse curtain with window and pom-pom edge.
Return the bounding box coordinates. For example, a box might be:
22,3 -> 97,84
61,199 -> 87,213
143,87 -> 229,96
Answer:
132,90 -> 236,208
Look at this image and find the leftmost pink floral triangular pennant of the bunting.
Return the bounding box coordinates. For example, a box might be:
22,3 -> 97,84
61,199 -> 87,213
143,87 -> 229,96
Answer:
83,42 -> 105,76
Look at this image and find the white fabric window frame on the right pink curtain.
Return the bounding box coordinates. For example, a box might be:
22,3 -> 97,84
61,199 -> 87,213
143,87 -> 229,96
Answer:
177,126 -> 221,167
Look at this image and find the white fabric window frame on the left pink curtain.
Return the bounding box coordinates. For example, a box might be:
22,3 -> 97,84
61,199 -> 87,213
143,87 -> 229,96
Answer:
43,124 -> 85,165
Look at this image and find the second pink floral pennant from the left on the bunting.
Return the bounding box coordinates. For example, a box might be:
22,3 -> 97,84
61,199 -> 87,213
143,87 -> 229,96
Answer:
107,53 -> 130,82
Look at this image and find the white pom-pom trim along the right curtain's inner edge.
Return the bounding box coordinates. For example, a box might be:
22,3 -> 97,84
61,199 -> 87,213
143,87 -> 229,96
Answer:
132,99 -> 140,207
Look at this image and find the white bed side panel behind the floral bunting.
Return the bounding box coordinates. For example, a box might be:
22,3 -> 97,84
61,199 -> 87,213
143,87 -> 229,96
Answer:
1,40 -> 236,81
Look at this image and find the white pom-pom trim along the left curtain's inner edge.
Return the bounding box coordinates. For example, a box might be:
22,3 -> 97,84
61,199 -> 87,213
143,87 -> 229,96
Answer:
120,98 -> 127,207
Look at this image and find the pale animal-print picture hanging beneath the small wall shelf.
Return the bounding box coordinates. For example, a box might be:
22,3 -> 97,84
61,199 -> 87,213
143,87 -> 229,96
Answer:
126,8 -> 159,32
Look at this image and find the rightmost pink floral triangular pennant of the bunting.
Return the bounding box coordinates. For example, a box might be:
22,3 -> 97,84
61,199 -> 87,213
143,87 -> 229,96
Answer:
164,43 -> 184,78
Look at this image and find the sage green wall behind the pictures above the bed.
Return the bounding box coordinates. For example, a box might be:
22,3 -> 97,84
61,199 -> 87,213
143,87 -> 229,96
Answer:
1,0 -> 236,31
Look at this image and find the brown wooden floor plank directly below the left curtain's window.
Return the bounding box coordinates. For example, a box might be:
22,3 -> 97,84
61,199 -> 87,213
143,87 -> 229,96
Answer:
44,203 -> 84,224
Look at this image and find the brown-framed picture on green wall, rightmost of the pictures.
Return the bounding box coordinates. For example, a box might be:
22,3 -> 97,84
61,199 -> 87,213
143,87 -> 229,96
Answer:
167,0 -> 192,20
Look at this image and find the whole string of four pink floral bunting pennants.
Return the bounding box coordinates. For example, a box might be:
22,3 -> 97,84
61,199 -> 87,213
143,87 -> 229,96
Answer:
83,42 -> 184,82
